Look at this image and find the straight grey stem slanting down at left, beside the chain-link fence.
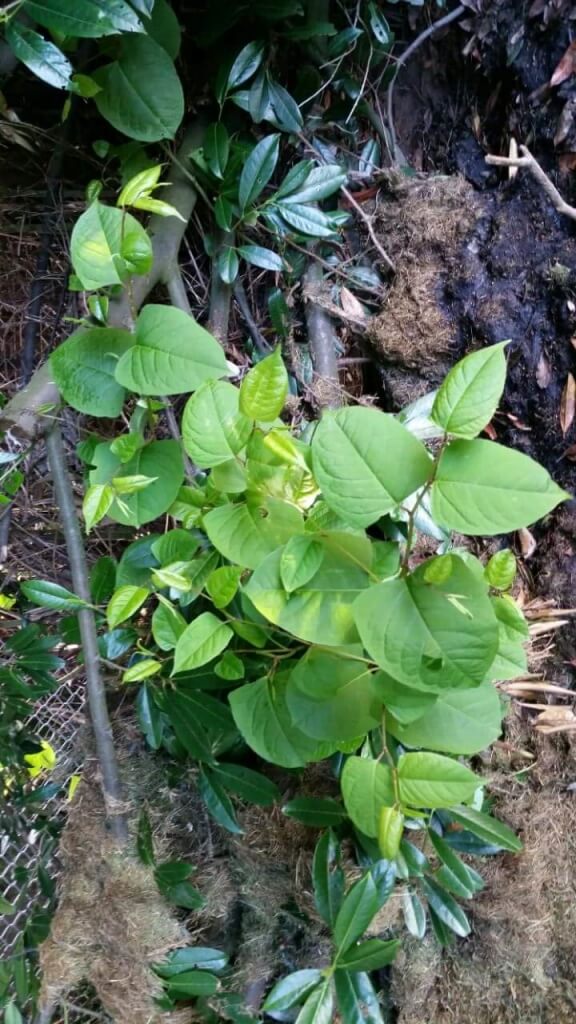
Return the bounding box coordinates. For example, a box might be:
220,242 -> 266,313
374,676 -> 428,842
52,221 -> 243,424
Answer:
46,424 -> 128,843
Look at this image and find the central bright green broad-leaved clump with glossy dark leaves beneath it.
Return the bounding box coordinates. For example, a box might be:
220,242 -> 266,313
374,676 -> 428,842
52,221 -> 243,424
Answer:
27,163 -> 568,1024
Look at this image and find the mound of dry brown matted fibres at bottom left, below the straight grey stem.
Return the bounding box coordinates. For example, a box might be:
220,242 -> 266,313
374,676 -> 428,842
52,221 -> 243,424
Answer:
39,770 -> 187,1024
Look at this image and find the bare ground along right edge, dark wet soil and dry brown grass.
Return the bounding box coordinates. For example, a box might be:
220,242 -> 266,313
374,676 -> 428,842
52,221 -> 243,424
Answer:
371,2 -> 576,1024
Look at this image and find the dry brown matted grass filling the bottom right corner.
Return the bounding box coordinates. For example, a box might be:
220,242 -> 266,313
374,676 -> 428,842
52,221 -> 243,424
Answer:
393,711 -> 576,1024
